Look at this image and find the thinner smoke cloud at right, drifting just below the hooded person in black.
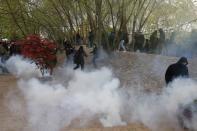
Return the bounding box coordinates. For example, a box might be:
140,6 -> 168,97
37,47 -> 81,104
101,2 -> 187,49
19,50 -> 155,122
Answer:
124,78 -> 197,131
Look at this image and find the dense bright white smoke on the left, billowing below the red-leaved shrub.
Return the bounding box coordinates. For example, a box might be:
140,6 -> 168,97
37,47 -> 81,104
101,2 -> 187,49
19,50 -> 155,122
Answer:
6,56 -> 125,131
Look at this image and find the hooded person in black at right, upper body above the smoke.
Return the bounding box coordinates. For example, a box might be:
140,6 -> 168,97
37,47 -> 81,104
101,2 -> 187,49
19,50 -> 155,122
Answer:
165,57 -> 189,84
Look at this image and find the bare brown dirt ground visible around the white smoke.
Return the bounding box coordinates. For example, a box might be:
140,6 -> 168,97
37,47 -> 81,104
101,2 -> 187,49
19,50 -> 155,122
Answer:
0,53 -> 197,131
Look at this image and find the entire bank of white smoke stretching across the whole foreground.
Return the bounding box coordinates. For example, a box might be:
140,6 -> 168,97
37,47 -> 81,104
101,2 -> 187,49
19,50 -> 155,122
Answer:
6,56 -> 197,131
